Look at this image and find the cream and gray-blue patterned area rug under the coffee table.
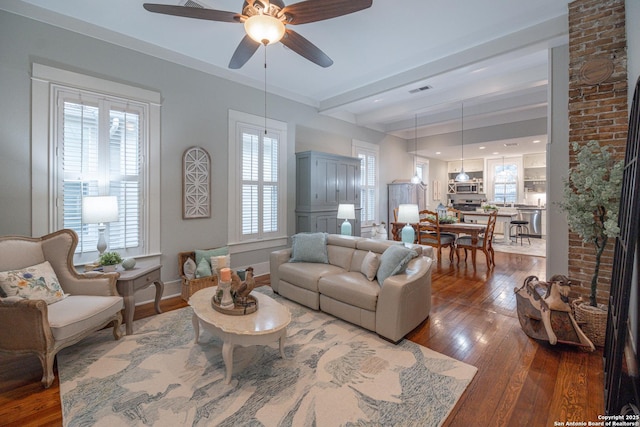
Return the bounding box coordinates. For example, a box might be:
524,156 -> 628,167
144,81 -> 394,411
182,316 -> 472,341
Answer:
58,287 -> 477,427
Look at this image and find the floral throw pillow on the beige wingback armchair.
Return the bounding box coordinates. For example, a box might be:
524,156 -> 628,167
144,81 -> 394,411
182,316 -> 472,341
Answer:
0,261 -> 67,304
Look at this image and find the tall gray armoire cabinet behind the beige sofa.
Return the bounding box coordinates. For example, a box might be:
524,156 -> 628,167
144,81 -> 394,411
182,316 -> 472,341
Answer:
296,151 -> 361,236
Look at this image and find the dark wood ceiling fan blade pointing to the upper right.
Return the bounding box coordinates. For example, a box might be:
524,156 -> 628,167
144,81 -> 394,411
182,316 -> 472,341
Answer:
282,0 -> 373,25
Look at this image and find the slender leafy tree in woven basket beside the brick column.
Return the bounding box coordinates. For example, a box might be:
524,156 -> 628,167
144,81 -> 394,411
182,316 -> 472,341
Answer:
559,141 -> 623,346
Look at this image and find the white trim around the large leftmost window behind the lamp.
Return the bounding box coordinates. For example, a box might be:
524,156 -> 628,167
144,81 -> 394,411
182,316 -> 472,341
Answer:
31,63 -> 161,256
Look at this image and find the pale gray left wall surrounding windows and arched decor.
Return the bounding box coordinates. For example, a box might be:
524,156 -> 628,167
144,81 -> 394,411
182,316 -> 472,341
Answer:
0,11 -> 400,281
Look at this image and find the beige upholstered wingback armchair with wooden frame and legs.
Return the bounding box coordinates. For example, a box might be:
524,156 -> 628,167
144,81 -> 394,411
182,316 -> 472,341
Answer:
0,230 -> 123,388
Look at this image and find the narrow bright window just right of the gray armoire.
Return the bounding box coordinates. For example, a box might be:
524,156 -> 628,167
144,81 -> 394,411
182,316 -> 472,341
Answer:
353,141 -> 379,227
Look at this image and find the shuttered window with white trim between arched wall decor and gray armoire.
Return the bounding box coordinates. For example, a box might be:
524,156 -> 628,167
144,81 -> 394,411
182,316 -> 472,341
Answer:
229,111 -> 287,251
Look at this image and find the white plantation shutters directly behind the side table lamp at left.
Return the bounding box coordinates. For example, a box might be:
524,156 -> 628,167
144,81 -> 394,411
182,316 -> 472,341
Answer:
55,88 -> 145,256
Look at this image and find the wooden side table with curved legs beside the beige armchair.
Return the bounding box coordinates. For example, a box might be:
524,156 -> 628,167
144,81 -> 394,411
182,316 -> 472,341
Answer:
116,262 -> 164,335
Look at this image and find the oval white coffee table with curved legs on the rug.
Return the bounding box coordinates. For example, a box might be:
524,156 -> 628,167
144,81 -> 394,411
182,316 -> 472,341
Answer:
189,286 -> 291,384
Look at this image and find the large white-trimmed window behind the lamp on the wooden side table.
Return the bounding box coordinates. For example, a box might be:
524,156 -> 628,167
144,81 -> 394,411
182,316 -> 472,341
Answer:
32,64 -> 160,263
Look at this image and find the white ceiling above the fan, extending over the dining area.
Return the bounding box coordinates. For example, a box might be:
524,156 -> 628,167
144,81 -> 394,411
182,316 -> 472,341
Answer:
0,0 -> 570,160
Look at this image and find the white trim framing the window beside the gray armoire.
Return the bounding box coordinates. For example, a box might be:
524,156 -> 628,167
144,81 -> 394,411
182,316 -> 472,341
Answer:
227,110 -> 289,253
